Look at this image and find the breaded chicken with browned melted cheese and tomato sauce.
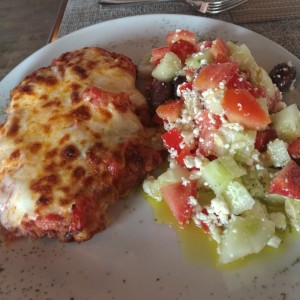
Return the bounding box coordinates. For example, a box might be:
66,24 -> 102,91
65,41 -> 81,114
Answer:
0,47 -> 163,242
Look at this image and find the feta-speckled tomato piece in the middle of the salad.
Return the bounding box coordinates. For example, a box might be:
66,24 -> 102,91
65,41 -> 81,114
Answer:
195,110 -> 222,158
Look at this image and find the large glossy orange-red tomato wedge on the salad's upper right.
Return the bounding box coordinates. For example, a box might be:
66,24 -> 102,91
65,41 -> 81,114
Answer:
221,89 -> 271,130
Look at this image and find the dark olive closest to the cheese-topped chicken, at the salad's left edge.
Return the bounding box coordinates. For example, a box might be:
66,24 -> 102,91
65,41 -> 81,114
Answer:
147,79 -> 173,114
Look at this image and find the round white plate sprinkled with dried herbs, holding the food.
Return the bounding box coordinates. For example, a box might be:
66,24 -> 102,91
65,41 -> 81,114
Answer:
0,15 -> 300,300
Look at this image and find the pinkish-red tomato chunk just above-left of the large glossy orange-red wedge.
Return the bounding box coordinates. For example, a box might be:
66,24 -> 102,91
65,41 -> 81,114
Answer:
193,62 -> 238,92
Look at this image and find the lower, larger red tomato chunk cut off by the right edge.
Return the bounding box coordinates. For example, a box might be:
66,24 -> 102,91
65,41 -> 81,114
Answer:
269,160 -> 300,200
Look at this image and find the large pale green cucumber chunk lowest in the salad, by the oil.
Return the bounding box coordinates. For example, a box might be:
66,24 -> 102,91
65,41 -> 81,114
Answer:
218,216 -> 275,264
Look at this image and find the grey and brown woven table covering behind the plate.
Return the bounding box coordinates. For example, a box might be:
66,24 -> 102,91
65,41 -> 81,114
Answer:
52,0 -> 300,58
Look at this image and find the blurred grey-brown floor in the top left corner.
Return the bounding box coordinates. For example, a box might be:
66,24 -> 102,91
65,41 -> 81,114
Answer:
0,0 -> 61,80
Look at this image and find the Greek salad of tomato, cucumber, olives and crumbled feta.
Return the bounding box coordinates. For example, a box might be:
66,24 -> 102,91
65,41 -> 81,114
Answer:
139,29 -> 300,264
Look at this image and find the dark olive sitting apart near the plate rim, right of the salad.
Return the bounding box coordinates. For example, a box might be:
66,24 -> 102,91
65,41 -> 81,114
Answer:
270,63 -> 296,92
